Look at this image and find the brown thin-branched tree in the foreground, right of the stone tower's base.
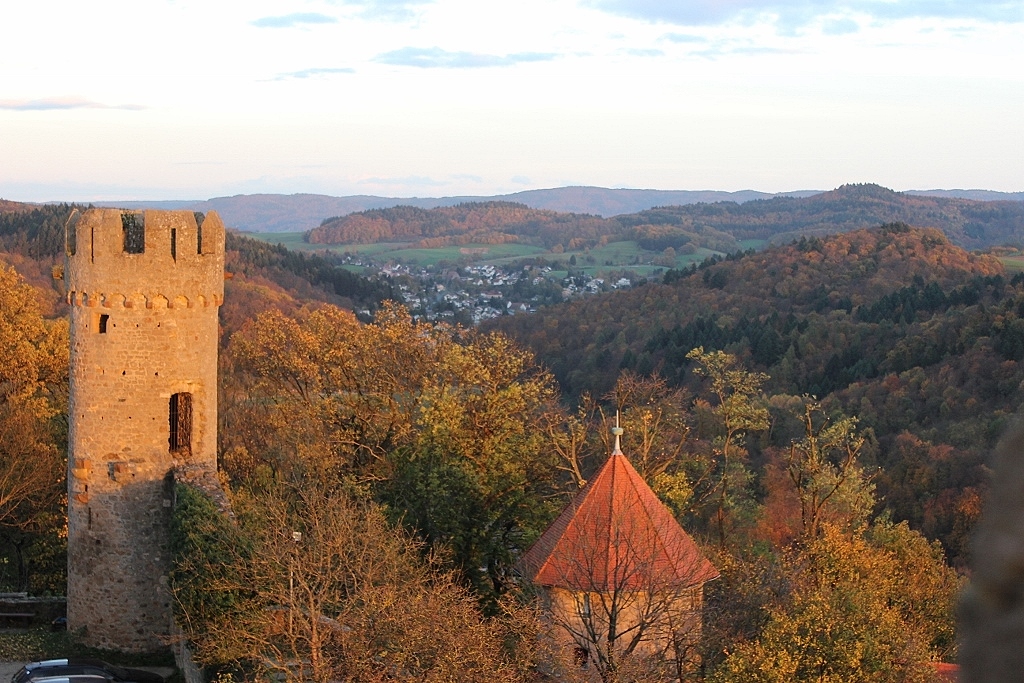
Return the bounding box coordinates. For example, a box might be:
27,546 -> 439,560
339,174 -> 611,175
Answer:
170,481 -> 521,683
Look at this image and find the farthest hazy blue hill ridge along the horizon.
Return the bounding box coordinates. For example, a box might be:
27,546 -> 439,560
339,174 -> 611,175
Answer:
81,186 -> 1024,232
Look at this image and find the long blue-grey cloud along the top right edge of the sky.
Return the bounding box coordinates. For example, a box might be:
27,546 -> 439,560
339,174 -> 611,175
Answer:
586,0 -> 1024,28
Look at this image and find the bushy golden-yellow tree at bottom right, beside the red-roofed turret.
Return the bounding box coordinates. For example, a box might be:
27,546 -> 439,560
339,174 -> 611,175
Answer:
712,524 -> 932,683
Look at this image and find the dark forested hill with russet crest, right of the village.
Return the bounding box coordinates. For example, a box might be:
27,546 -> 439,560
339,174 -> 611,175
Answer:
494,224 -> 1024,556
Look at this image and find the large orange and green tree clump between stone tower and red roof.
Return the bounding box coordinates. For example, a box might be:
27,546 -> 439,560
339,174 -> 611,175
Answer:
222,305 -> 555,608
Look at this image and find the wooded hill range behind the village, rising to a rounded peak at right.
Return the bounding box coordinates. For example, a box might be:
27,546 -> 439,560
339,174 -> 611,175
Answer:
308,184 -> 1024,252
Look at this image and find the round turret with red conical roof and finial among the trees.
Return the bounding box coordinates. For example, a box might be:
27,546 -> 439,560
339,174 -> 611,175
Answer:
517,427 -> 719,680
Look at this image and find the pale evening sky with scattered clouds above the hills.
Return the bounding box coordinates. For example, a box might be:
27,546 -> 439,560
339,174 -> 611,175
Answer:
0,0 -> 1024,202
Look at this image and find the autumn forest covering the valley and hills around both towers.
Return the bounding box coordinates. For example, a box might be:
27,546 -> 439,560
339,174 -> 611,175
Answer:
0,186 -> 1024,683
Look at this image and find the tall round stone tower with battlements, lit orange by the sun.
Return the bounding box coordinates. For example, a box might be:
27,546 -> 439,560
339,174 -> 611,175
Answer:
65,209 -> 224,651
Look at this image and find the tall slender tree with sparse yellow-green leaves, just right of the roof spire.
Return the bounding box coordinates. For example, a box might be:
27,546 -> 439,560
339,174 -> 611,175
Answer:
686,346 -> 768,547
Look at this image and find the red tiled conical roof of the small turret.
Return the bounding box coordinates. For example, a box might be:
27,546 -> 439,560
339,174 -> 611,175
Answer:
517,450 -> 719,592
